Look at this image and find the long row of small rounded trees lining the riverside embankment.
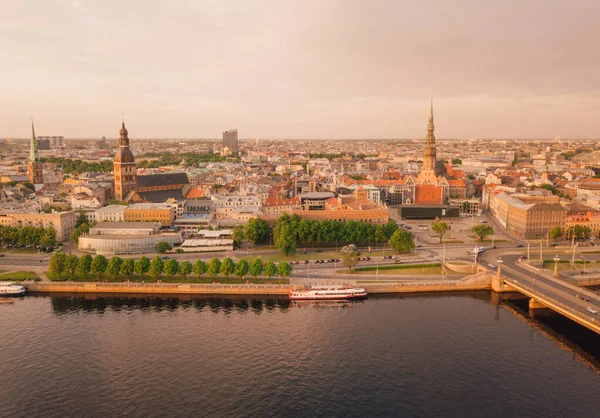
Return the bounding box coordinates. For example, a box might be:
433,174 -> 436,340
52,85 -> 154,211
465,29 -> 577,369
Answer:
48,253 -> 292,280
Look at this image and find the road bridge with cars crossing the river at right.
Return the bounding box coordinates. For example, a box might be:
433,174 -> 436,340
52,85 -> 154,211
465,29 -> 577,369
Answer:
492,255 -> 600,334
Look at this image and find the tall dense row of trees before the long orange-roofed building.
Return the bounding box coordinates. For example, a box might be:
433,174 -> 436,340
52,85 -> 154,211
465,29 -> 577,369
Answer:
273,214 -> 398,255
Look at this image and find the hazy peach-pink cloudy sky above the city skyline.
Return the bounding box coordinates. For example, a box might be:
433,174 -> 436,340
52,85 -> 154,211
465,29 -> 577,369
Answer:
0,0 -> 600,138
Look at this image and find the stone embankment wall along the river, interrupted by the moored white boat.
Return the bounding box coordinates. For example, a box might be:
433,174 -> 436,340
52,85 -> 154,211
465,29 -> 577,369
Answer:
22,273 -> 491,296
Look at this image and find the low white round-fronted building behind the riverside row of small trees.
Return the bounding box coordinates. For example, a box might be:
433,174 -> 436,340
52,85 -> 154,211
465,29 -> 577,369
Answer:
78,222 -> 182,256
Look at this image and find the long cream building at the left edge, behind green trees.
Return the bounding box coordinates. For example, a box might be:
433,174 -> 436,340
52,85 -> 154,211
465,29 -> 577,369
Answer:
0,207 -> 78,241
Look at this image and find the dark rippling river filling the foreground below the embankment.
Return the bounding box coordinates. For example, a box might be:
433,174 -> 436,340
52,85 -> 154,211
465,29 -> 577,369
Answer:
0,292 -> 600,417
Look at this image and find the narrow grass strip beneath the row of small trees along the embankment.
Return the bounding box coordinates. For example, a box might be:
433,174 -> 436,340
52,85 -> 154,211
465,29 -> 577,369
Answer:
46,272 -> 288,284
